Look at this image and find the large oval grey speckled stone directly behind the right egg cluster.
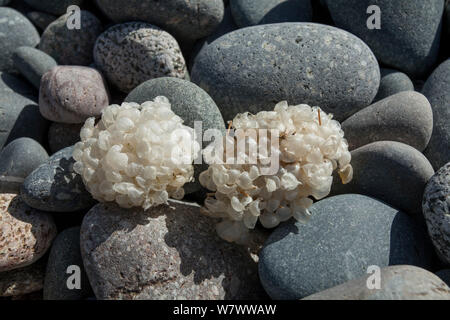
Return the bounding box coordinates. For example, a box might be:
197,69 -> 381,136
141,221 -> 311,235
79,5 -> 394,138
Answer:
191,22 -> 380,121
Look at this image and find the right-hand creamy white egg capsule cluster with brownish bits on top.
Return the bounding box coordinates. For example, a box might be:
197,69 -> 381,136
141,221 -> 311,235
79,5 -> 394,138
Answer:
199,102 -> 353,242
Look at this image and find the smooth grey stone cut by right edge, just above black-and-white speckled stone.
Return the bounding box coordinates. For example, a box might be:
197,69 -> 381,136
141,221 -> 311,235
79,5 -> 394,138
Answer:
422,59 -> 450,170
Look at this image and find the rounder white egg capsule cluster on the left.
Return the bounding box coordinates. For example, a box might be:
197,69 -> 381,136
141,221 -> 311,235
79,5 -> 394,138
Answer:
73,97 -> 200,209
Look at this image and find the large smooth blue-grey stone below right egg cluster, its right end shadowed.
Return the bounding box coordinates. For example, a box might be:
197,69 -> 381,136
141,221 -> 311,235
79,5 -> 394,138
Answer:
258,194 -> 430,299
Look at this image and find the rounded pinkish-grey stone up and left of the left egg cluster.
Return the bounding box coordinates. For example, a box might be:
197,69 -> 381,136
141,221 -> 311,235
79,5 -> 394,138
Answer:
39,66 -> 109,123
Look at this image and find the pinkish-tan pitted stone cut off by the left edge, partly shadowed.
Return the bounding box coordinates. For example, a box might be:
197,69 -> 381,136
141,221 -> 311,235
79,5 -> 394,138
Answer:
0,193 -> 56,272
